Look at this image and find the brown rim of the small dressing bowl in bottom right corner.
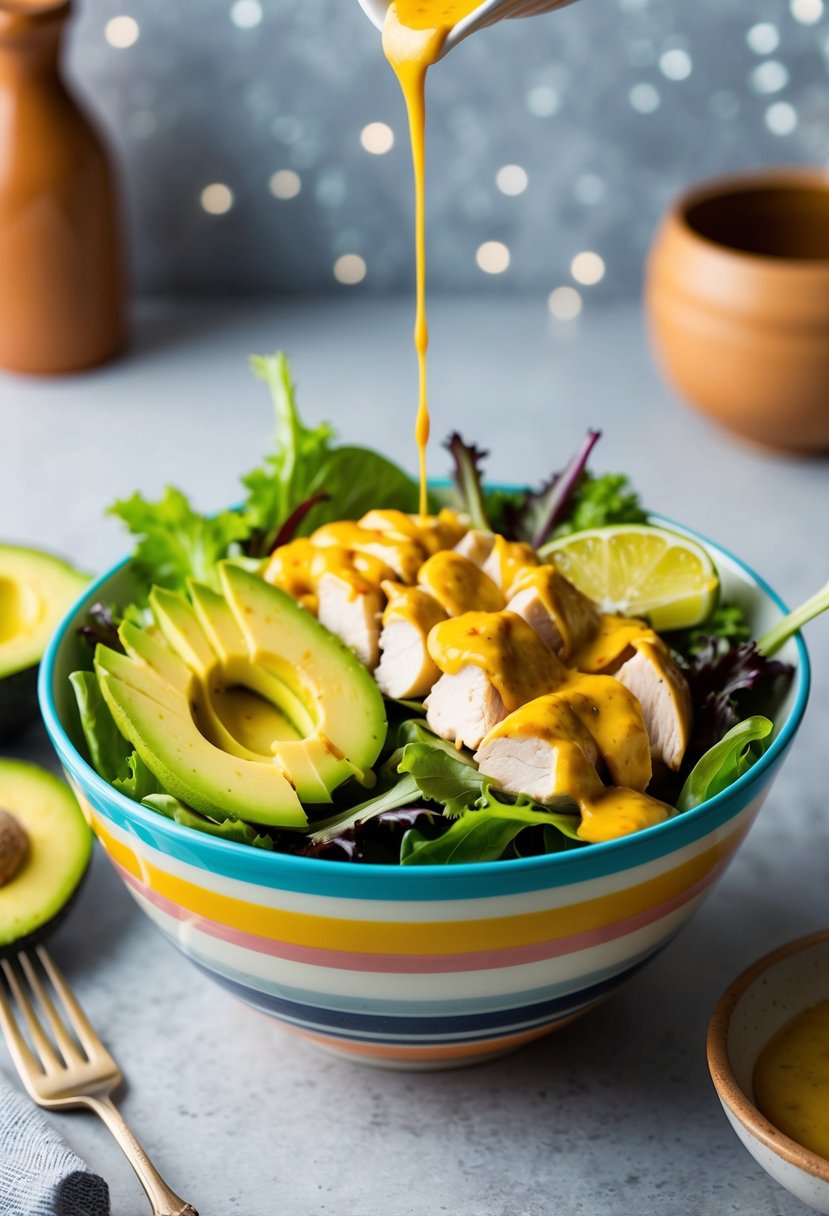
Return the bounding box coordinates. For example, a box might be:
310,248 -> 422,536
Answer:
706,929 -> 829,1183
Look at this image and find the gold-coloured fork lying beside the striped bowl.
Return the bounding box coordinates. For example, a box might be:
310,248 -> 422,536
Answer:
0,946 -> 198,1216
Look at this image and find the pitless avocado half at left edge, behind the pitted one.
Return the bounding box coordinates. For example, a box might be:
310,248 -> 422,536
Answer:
0,545 -> 89,739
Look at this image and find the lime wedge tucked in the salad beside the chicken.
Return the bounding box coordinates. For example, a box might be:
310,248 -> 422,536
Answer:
540,524 -> 720,630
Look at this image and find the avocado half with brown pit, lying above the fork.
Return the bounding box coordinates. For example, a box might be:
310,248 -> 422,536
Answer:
0,760 -> 92,956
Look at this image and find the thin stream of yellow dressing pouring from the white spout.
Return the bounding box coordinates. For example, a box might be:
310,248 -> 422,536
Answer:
383,0 -> 480,516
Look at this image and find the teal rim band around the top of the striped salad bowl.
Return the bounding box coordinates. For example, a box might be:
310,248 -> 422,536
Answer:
38,514 -> 811,885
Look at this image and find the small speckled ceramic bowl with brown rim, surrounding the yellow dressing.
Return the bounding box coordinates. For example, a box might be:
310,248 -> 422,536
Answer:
707,929 -> 829,1216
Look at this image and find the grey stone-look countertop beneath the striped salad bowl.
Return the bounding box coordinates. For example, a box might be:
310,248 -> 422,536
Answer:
0,295 -> 829,1216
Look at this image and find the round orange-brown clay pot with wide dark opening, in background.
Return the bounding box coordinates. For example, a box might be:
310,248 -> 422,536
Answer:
645,169 -> 829,452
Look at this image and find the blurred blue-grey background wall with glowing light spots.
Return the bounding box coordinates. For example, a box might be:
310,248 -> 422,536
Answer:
71,0 -> 829,298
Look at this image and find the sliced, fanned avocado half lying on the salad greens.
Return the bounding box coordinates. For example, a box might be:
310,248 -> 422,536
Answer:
95,563 -> 387,828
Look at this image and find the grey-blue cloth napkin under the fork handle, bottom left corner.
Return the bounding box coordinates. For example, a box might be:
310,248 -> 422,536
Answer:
0,1079 -> 109,1216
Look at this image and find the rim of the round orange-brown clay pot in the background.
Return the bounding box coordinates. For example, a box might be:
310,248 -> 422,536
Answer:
666,165 -> 829,274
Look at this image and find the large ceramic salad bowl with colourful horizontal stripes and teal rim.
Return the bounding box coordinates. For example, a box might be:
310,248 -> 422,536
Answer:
40,527 -> 810,1068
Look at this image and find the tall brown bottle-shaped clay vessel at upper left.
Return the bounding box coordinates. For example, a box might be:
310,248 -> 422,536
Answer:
0,0 -> 125,375
